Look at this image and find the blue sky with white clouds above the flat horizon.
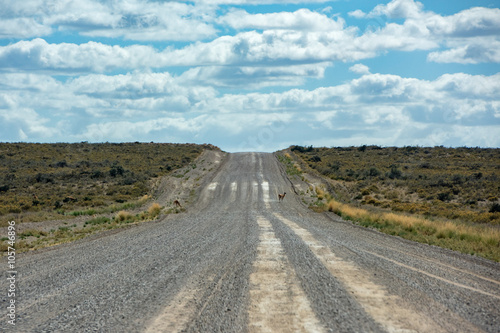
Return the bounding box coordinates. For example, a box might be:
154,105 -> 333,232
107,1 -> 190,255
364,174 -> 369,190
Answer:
0,0 -> 500,151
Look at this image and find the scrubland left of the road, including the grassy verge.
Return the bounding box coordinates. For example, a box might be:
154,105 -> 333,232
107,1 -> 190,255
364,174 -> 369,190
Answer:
0,142 -> 218,252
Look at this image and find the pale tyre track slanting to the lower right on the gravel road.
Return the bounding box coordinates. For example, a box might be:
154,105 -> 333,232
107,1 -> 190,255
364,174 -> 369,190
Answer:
274,213 -> 443,332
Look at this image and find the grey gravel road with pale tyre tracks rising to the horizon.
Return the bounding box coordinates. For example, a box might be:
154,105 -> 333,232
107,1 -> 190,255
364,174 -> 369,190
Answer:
0,153 -> 500,332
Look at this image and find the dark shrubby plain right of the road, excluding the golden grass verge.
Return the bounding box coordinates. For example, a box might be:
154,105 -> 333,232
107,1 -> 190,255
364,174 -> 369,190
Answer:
290,146 -> 500,225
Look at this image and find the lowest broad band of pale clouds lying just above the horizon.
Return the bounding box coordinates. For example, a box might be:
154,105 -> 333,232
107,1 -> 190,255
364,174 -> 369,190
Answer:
0,70 -> 500,150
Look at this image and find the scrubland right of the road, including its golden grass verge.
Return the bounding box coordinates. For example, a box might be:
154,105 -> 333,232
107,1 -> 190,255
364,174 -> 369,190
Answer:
284,146 -> 500,261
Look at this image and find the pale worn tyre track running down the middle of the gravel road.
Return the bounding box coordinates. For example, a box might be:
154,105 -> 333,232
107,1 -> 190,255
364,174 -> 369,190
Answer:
248,217 -> 324,332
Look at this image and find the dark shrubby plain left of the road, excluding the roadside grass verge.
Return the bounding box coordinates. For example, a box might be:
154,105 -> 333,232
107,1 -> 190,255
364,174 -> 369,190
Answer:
0,142 -> 215,226
